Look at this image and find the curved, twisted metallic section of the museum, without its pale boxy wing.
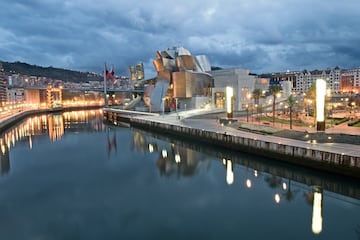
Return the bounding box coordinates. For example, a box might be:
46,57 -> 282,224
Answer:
150,47 -> 214,111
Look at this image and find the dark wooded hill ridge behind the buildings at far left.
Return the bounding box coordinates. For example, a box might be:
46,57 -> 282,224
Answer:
0,61 -> 102,83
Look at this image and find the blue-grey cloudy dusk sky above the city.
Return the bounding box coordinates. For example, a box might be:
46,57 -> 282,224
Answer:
0,0 -> 360,78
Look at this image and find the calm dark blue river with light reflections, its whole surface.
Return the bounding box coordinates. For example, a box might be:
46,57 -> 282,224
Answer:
0,110 -> 360,240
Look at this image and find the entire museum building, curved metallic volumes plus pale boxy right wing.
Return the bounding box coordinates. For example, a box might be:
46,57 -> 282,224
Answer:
144,47 -> 268,112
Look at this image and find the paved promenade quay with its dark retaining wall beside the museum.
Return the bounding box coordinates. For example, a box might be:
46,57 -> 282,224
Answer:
104,108 -> 360,178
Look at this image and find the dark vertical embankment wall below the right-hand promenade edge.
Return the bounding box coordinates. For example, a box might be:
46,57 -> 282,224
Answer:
129,118 -> 360,178
